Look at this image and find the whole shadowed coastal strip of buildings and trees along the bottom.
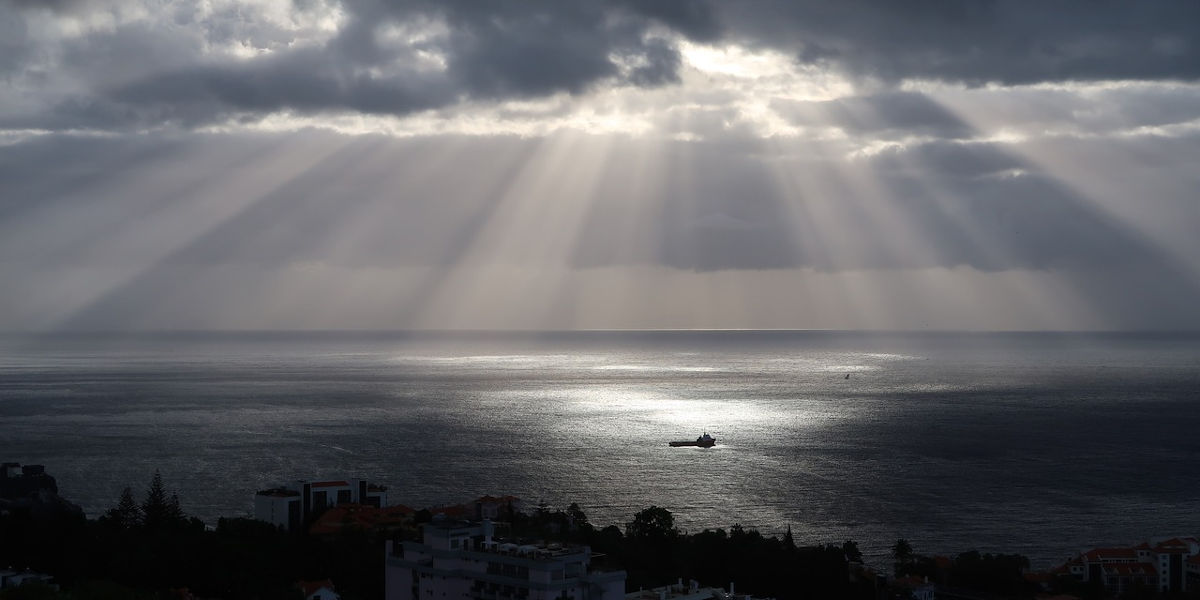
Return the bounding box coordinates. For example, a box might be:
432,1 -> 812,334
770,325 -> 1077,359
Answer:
0,463 -> 1200,600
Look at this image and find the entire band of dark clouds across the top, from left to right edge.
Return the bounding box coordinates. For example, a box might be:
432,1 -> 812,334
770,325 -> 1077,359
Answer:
9,0 -> 1200,128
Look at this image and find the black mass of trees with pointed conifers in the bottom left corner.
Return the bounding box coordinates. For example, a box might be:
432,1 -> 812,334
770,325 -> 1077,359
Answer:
0,474 -> 383,600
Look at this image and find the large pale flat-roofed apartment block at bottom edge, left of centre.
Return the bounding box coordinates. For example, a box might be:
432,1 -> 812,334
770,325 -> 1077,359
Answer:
384,520 -> 625,600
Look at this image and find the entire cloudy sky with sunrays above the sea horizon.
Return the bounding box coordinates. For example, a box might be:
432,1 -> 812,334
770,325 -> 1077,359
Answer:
0,0 -> 1200,331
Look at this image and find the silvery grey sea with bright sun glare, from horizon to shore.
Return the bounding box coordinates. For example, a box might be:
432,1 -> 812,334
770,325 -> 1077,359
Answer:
0,331 -> 1200,566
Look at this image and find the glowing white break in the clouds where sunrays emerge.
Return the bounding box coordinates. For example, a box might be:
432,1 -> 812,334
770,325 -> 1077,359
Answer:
202,39 -> 854,140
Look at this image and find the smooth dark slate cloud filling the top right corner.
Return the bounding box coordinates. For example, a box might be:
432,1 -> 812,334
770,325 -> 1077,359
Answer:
719,0 -> 1200,84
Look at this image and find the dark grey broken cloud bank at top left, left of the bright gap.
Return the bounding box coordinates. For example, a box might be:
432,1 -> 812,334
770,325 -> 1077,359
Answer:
7,1 -> 704,128
